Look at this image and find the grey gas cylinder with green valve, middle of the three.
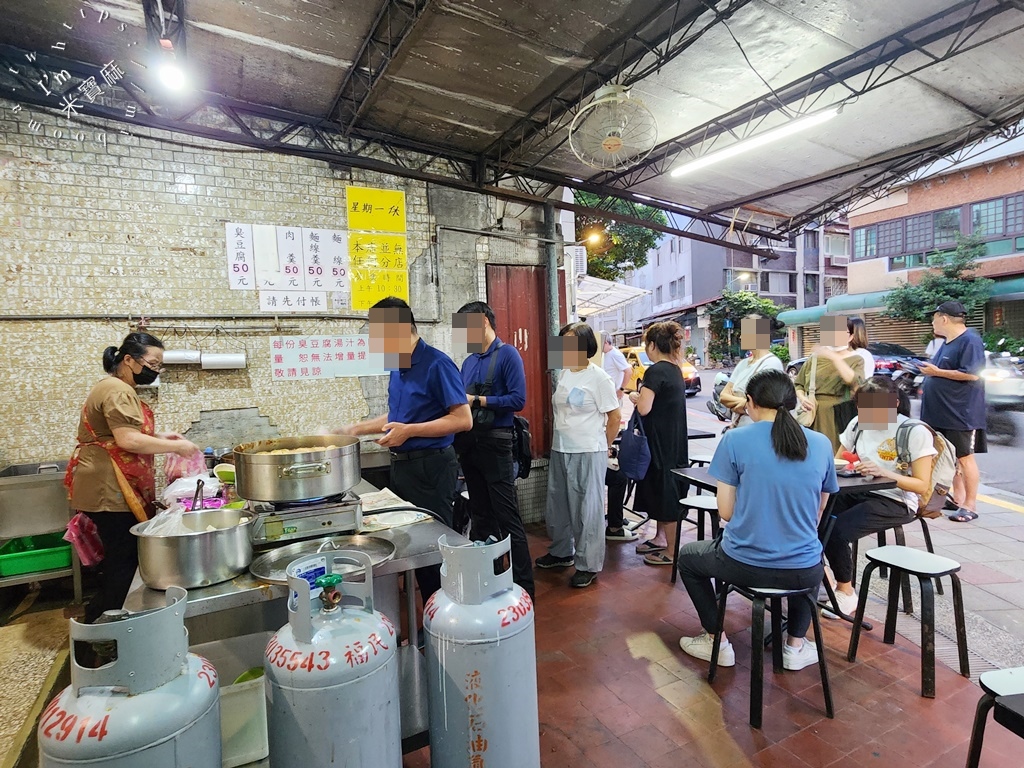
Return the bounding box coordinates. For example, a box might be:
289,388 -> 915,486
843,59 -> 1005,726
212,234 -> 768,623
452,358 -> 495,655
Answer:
263,550 -> 401,768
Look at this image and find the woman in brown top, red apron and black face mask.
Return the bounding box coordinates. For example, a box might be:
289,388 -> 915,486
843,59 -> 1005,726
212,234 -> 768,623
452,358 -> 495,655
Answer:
65,333 -> 199,623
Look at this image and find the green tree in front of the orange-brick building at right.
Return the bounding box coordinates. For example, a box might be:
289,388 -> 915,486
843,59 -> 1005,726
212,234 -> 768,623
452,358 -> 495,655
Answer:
885,234 -> 992,322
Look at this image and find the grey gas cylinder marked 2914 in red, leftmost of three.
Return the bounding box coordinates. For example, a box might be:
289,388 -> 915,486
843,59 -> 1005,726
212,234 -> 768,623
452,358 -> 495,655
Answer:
38,587 -> 220,768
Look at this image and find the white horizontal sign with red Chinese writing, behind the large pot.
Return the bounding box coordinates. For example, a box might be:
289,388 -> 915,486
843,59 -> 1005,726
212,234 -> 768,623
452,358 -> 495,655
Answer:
270,336 -> 387,381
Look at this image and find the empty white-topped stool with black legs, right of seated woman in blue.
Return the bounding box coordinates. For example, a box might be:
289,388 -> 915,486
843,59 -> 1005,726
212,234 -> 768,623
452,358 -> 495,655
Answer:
847,546 -> 971,698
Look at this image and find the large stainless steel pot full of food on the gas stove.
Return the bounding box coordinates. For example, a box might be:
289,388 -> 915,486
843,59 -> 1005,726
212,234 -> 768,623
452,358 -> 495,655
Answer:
234,435 -> 359,502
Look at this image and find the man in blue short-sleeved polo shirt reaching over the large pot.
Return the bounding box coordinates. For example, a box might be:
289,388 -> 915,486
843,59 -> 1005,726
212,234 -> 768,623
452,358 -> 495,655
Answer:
337,297 -> 473,603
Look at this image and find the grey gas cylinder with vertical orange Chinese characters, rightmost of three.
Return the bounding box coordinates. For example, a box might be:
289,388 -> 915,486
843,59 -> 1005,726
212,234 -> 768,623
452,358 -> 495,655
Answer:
423,536 -> 541,768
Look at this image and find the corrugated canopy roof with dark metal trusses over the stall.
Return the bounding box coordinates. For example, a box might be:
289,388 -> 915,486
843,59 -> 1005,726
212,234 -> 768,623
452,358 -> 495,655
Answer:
6,0 -> 1024,231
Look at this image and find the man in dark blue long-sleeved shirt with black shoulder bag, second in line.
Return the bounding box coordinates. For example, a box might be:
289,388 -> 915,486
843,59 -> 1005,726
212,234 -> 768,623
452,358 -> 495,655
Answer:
452,301 -> 534,598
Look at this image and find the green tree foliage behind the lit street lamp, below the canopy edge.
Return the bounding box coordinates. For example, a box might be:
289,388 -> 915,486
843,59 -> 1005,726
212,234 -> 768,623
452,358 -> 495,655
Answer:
575,193 -> 669,280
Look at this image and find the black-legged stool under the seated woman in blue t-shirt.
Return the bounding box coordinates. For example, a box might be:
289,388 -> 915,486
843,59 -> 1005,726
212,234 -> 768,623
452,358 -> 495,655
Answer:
708,583 -> 836,728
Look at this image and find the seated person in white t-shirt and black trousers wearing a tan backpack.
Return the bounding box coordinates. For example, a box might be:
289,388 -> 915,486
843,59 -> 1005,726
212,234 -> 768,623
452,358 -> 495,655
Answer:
824,376 -> 937,618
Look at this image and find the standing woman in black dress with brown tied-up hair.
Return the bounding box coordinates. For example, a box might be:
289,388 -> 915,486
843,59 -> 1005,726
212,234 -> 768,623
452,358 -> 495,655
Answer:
630,322 -> 688,565
